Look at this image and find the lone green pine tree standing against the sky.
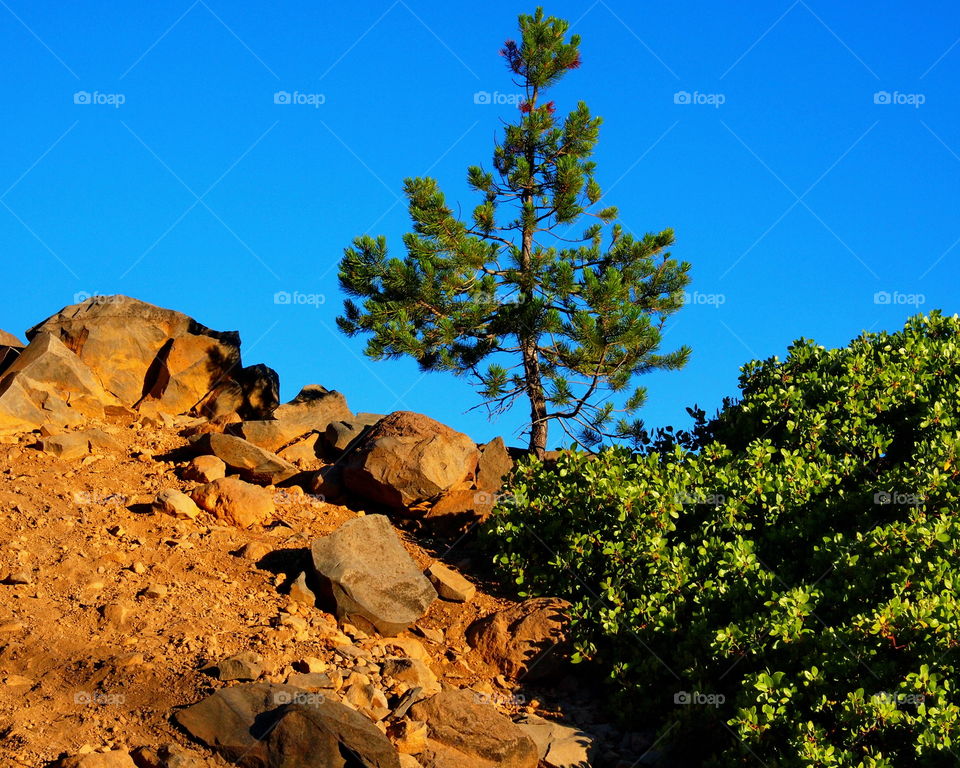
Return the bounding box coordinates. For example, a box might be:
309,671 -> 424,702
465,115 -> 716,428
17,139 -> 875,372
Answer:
337,8 -> 690,453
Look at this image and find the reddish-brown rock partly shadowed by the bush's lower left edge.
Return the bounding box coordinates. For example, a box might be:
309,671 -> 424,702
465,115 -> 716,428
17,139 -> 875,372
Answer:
466,597 -> 570,681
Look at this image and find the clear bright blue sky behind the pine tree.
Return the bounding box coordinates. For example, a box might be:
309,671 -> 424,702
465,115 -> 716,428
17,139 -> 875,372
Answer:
0,0 -> 960,450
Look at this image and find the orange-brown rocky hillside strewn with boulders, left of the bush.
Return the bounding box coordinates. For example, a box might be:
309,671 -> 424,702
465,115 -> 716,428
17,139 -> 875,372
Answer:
0,296 -> 649,768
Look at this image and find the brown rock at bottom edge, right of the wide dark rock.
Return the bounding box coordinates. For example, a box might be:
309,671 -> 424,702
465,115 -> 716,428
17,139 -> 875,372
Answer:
410,688 -> 539,768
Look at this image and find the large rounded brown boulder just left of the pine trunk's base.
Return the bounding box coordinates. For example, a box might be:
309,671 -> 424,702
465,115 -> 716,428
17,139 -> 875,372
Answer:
343,411 -> 480,509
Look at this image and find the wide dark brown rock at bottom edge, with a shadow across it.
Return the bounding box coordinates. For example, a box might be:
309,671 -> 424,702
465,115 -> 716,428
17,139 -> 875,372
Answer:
174,683 -> 400,768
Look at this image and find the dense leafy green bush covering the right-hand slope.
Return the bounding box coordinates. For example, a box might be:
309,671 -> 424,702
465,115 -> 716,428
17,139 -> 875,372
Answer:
488,313 -> 960,768
